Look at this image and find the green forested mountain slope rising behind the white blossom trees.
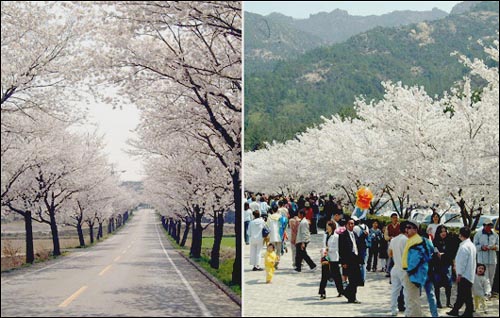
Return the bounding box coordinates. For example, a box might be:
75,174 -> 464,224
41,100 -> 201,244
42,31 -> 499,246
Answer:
244,3 -> 499,151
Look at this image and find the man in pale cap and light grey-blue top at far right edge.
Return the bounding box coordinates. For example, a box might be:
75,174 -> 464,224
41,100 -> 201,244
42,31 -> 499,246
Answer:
474,220 -> 498,285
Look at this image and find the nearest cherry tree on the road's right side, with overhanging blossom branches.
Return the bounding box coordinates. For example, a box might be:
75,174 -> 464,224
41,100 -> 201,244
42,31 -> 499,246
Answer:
96,1 -> 241,283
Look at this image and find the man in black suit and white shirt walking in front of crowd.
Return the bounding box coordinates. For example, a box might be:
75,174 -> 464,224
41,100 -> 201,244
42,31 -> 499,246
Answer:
339,219 -> 362,304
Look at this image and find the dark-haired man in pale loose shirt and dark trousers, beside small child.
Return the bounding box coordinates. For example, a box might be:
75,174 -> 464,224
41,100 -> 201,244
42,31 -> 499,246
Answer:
446,227 -> 477,317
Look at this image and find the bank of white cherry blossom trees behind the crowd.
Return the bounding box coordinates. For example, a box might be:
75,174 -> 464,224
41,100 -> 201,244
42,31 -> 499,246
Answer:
245,40 -> 499,228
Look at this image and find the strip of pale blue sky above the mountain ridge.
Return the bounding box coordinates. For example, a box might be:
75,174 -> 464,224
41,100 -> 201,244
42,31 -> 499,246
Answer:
243,1 -> 462,19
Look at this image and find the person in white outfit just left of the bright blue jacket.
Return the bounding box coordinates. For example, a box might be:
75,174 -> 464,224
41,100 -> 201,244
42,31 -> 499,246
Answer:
388,223 -> 408,316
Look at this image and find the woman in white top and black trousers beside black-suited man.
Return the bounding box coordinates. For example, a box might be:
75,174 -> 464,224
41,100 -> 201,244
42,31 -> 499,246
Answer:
319,220 -> 344,299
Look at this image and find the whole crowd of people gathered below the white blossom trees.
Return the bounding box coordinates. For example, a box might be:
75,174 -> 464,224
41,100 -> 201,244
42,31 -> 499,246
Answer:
244,194 -> 498,317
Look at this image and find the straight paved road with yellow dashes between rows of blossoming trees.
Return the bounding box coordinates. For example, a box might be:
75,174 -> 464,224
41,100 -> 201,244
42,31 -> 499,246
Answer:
1,210 -> 240,317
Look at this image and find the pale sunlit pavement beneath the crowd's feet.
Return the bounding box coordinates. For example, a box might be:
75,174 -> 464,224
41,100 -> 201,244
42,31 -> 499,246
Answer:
243,233 -> 499,317
